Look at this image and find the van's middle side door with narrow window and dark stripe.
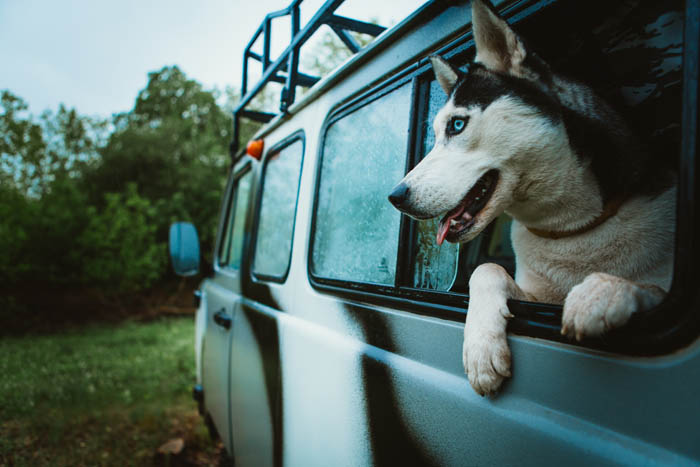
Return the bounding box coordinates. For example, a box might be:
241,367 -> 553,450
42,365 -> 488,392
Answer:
231,132 -> 304,466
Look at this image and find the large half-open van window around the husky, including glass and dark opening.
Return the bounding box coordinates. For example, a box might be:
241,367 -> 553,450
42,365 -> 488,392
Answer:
309,0 -> 698,353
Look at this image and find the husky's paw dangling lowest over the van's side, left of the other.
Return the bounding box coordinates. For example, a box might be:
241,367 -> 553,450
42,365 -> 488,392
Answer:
462,332 -> 511,396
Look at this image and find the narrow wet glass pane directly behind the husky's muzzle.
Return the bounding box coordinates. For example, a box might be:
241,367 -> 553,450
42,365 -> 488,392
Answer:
413,80 -> 458,290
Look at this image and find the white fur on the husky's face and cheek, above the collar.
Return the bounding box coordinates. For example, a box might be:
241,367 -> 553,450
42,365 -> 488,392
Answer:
403,96 -> 580,242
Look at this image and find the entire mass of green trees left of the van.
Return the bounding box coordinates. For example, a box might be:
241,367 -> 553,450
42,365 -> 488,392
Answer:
0,66 -> 237,300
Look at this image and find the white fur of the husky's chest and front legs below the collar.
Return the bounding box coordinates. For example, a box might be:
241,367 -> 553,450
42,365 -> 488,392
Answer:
463,188 -> 676,395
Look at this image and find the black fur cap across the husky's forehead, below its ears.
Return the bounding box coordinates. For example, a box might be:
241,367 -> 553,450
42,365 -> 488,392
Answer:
451,63 -> 561,126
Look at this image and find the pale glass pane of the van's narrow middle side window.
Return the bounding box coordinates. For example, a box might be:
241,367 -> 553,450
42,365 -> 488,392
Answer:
253,139 -> 304,278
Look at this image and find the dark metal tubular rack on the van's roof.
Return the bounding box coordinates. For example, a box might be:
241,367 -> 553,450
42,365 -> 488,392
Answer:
229,0 -> 386,160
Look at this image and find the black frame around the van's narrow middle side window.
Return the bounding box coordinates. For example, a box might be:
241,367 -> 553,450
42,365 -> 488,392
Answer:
248,130 -> 306,284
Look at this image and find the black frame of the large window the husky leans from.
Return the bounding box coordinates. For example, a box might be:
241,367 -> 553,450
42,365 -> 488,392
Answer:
307,0 -> 700,356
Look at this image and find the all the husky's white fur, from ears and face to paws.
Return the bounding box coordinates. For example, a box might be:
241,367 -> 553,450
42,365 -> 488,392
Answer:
392,0 -> 676,395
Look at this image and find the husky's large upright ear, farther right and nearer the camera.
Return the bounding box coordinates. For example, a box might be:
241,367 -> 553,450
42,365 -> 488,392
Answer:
472,0 -> 527,76
